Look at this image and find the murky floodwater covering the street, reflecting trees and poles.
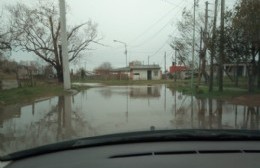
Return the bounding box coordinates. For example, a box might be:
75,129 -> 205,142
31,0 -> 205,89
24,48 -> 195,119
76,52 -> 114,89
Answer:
0,85 -> 260,155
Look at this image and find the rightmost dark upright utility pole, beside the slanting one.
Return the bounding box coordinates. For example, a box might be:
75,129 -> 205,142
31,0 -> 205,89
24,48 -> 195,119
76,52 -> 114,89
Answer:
218,0 -> 225,92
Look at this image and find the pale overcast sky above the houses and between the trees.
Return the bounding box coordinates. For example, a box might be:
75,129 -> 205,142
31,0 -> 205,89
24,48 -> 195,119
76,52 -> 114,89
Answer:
0,0 -> 235,70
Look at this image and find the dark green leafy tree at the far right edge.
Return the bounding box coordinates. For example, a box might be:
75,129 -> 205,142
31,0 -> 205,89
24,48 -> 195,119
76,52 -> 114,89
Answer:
233,0 -> 260,92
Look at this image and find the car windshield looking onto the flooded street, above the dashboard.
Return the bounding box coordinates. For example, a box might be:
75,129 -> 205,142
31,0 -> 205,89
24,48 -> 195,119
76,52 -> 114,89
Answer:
0,0 -> 260,156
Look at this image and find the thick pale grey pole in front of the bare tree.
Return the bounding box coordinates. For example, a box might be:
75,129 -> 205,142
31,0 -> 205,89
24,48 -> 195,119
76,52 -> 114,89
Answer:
60,0 -> 71,90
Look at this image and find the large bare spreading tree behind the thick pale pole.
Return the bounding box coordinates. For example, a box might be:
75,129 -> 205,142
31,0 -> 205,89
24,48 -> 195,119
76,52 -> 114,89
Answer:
8,1 -> 98,82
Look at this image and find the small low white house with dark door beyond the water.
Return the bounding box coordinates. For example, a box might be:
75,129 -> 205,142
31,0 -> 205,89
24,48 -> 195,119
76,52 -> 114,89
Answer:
111,61 -> 162,80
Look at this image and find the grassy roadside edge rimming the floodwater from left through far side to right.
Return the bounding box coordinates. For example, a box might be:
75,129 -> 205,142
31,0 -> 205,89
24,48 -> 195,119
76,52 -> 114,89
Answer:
0,80 -> 260,106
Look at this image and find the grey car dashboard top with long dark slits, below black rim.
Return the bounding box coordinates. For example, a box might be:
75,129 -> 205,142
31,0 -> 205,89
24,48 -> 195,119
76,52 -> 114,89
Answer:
4,141 -> 260,168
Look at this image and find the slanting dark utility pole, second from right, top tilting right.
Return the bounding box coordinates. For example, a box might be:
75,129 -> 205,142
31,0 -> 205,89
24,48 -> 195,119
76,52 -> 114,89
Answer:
209,0 -> 218,92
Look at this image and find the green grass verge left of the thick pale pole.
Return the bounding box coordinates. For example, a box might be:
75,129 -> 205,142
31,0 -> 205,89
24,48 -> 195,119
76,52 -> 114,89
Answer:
0,84 -> 65,105
